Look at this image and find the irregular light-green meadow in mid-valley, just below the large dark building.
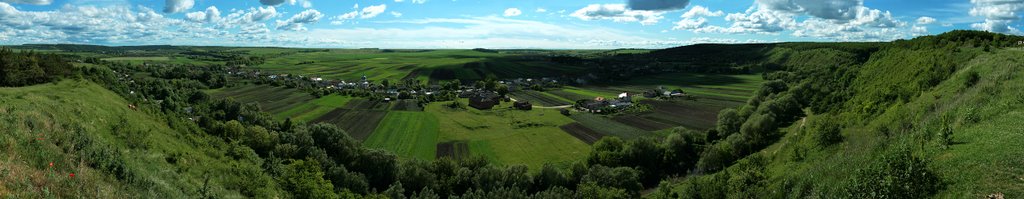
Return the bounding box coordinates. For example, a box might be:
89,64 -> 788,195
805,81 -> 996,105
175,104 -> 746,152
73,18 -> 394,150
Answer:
426,100 -> 590,168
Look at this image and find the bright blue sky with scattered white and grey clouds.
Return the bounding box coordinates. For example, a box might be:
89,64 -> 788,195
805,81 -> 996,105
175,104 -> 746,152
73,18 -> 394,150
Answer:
0,0 -> 1024,49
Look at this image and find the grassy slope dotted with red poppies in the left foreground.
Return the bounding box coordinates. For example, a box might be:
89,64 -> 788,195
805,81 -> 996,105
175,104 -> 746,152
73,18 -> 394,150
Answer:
0,80 -> 278,198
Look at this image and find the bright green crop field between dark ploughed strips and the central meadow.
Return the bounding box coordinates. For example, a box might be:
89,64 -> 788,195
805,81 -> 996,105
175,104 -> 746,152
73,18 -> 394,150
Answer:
362,111 -> 438,160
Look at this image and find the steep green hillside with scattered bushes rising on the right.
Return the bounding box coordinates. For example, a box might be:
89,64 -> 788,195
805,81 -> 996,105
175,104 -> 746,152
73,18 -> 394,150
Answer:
651,32 -> 1024,198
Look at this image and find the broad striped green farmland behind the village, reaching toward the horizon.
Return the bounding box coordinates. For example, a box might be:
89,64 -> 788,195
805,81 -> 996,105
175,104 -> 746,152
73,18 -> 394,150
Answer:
250,49 -> 583,81
